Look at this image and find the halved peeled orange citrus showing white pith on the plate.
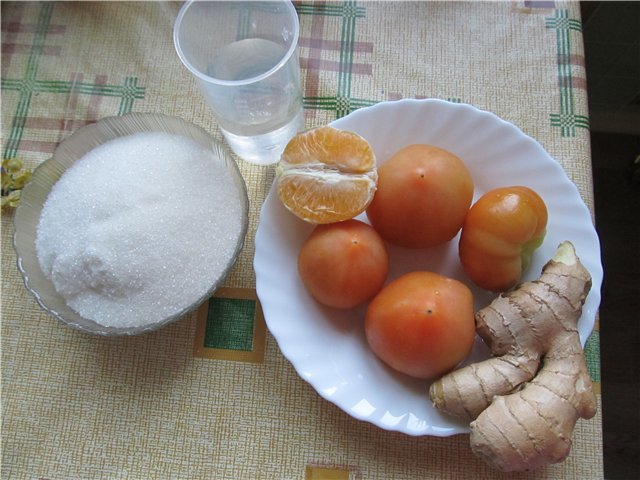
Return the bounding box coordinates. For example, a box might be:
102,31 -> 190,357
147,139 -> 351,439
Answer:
276,126 -> 378,224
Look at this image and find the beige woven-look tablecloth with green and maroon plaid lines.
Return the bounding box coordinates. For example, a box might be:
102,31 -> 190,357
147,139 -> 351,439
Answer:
2,1 -> 602,479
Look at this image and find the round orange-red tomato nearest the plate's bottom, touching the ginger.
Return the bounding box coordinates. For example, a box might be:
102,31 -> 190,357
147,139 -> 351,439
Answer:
364,271 -> 475,379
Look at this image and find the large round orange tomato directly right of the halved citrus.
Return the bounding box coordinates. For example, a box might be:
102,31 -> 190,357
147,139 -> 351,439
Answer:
367,144 -> 473,248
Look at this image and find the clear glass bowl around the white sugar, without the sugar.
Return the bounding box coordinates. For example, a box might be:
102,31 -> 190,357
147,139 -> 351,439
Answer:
13,113 -> 249,336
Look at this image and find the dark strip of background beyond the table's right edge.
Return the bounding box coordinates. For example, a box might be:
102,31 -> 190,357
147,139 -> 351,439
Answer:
581,1 -> 640,480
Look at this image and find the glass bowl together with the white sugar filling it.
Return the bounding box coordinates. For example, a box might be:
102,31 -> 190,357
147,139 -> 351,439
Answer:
13,113 -> 249,336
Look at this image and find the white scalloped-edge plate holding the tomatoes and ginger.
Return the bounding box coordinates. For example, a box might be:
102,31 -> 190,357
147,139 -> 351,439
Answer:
254,100 -> 602,436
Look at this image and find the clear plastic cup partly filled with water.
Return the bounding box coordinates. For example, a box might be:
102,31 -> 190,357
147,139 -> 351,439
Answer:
173,0 -> 304,165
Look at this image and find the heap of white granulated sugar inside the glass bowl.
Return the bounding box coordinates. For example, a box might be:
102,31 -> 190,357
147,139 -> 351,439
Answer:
36,132 -> 243,327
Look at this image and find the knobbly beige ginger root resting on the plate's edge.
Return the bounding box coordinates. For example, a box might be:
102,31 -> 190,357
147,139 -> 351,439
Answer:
429,242 -> 596,471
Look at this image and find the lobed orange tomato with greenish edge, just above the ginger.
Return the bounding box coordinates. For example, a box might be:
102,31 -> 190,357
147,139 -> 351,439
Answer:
458,186 -> 547,292
